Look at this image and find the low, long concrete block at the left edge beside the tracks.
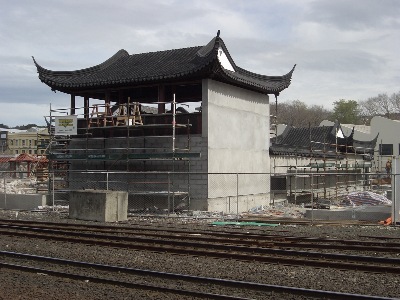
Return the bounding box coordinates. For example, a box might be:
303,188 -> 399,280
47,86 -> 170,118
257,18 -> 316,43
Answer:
0,194 -> 47,210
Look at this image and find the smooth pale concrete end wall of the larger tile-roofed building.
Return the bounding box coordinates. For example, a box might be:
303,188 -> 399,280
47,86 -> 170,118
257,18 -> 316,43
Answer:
202,79 -> 270,210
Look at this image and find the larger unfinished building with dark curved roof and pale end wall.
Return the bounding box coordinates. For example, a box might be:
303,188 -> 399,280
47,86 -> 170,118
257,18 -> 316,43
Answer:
34,32 -> 294,211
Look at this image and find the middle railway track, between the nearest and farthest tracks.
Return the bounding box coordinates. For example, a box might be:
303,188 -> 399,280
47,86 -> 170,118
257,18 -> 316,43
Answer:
0,226 -> 400,274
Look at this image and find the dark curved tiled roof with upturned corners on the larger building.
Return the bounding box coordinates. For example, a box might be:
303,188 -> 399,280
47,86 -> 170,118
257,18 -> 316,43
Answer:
33,34 -> 294,94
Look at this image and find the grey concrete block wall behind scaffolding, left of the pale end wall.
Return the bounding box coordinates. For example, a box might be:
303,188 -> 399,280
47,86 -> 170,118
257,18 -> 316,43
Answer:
70,135 -> 207,209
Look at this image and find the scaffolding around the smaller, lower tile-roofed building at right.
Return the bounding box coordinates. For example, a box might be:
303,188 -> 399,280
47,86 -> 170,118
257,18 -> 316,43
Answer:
271,130 -> 375,204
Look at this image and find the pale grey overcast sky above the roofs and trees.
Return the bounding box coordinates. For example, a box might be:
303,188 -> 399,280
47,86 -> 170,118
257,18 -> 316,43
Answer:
0,0 -> 400,126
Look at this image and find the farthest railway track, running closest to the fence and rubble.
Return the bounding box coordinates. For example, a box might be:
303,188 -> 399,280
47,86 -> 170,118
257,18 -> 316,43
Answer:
0,220 -> 400,252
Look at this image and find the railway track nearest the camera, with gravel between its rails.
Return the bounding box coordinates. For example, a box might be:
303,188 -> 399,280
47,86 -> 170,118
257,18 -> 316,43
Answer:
0,251 -> 394,300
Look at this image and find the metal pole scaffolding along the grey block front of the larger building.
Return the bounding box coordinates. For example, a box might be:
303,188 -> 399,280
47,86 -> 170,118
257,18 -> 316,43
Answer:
46,95 -> 201,212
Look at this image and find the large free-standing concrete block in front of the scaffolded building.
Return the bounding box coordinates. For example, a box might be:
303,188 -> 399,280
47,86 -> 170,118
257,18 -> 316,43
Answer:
69,190 -> 128,222
